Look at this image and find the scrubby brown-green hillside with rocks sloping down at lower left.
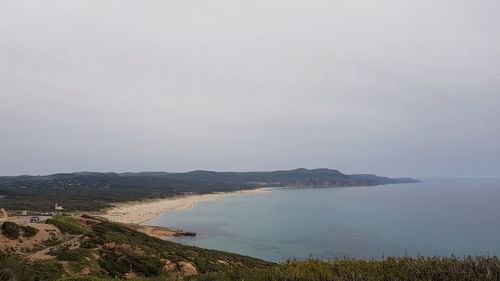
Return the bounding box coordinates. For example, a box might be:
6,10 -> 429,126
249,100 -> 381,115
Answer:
0,215 -> 272,281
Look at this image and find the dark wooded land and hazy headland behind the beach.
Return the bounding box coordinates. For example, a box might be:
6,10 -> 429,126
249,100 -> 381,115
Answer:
0,169 -> 417,211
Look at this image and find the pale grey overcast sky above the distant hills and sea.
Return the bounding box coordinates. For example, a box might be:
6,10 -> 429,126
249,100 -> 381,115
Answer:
0,0 -> 500,177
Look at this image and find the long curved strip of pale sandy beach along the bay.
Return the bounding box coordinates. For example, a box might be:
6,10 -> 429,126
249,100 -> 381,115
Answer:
102,188 -> 270,224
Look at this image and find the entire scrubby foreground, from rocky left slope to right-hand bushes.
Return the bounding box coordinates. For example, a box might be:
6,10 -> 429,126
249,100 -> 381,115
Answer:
0,216 -> 500,281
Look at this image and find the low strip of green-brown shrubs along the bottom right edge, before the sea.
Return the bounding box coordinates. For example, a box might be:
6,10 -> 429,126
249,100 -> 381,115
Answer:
191,257 -> 500,281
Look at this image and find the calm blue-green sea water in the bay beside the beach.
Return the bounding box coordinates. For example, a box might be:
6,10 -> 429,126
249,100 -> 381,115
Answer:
150,179 -> 500,261
